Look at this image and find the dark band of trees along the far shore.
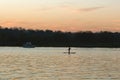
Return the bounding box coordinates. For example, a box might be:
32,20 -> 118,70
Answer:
0,28 -> 120,47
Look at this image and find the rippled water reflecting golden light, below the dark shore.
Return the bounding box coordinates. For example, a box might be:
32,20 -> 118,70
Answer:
0,47 -> 120,80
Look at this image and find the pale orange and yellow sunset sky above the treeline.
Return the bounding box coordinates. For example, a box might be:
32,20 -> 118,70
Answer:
0,0 -> 120,31
